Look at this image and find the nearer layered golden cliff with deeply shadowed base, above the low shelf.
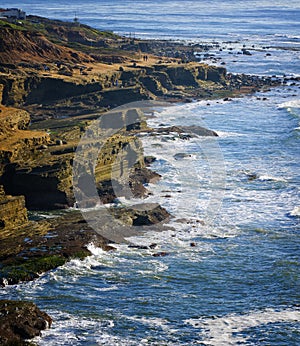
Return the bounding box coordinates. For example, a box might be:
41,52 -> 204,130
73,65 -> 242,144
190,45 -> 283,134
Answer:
0,98 -> 152,210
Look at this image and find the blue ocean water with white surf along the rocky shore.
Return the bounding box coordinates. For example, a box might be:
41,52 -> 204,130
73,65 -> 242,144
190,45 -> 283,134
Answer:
0,0 -> 300,346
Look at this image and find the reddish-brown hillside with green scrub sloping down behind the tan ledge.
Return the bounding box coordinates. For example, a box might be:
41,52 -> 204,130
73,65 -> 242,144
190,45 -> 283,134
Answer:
0,16 -> 202,69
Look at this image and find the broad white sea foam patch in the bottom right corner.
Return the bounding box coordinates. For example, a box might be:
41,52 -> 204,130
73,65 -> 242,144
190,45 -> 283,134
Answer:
185,309 -> 300,346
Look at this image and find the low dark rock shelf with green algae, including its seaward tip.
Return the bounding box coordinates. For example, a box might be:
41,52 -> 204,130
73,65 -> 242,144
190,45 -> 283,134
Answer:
0,203 -> 170,286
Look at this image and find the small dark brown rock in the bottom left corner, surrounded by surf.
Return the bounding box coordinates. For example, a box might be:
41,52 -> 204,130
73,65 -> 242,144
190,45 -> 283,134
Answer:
0,300 -> 52,346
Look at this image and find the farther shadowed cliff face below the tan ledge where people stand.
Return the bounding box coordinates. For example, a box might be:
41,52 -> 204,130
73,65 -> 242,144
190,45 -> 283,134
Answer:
0,63 -> 226,108
